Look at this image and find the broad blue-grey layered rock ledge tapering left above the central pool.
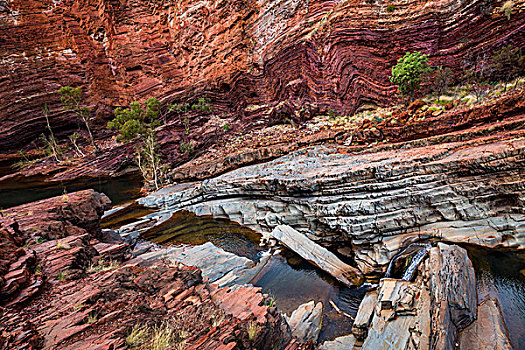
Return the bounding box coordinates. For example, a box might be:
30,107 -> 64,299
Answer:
140,124 -> 525,274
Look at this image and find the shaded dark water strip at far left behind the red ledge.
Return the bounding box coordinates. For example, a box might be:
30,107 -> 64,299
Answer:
0,174 -> 142,209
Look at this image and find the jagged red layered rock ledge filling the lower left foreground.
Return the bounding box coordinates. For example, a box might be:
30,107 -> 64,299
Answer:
0,190 -> 294,349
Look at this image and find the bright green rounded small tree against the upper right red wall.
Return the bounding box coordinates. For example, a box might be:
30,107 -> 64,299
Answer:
390,51 -> 431,102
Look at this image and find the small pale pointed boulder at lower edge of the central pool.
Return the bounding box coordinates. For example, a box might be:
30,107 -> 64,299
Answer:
285,300 -> 323,343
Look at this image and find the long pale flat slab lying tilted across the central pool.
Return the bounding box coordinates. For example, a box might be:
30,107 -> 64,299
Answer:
262,225 -> 363,286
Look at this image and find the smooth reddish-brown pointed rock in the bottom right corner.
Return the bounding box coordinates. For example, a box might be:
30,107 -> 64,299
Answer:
458,299 -> 512,350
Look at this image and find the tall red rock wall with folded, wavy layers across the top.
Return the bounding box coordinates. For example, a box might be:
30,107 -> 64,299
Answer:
0,0 -> 525,153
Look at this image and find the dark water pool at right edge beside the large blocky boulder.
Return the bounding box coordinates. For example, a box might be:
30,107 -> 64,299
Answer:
466,246 -> 525,349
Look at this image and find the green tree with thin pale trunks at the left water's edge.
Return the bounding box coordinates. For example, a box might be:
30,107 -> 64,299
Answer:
108,98 -> 163,189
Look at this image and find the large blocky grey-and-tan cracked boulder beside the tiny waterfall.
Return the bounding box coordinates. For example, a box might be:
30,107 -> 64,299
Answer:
358,243 -> 477,349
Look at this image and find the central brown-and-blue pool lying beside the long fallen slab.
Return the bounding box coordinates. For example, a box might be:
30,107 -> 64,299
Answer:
139,212 -> 366,341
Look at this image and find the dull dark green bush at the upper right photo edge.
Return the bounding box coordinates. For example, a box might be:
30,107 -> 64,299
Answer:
490,44 -> 525,91
